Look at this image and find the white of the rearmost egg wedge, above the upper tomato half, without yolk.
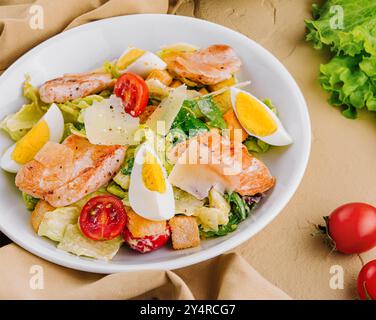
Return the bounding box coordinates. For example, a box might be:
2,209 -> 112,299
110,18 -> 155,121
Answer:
120,47 -> 167,78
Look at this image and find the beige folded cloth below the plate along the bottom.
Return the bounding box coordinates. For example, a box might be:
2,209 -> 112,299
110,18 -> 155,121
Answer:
0,244 -> 289,300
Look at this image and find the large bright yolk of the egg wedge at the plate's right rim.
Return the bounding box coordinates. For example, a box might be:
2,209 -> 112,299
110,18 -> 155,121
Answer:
235,92 -> 277,137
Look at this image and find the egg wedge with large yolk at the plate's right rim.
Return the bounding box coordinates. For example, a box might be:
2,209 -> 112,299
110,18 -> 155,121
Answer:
230,87 -> 292,146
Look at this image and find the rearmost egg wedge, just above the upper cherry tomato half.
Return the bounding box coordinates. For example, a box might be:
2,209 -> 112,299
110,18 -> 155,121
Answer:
116,47 -> 167,78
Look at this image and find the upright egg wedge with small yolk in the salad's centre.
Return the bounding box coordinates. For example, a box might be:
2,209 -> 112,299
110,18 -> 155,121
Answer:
128,143 -> 175,221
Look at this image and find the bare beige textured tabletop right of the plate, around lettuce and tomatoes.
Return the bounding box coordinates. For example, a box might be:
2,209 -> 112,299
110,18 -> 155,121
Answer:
173,0 -> 376,299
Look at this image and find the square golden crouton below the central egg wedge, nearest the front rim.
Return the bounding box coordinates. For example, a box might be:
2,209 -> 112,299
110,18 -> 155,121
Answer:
169,216 -> 200,250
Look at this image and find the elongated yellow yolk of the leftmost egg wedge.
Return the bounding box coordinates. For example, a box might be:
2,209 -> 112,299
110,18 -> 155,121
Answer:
12,120 -> 50,164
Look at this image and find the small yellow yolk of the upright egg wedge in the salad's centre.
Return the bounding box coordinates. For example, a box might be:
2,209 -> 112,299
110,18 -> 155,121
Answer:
142,152 -> 166,193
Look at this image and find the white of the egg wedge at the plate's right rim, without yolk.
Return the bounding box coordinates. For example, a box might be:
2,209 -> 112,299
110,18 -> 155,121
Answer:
230,87 -> 293,146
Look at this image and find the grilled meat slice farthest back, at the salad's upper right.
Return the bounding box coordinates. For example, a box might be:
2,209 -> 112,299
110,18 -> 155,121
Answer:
164,44 -> 241,85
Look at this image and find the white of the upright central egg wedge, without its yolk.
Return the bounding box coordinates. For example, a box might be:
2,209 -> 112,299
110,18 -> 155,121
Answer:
128,143 -> 175,221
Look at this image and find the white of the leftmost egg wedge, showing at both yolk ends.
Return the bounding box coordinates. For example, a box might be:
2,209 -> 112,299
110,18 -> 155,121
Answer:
0,103 -> 64,173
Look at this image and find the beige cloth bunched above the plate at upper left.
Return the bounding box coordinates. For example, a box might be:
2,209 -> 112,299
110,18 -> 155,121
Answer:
0,0 -> 168,70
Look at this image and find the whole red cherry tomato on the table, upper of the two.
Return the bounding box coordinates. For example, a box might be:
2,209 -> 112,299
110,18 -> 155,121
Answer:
327,203 -> 376,254
